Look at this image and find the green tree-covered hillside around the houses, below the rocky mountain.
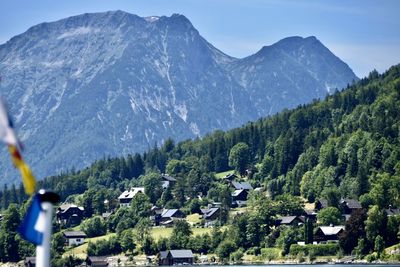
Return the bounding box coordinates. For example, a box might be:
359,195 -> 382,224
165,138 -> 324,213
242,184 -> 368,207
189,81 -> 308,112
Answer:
0,65 -> 400,262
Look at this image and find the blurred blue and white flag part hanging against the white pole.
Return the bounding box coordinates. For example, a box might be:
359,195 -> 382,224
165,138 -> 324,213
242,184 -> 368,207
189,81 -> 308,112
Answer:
18,194 -> 45,245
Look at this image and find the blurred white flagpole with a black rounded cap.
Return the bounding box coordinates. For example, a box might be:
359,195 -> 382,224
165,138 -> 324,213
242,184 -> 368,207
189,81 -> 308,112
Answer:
36,189 -> 60,267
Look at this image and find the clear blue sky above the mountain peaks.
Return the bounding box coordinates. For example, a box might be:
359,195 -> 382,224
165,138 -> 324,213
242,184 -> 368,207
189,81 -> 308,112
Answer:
0,0 -> 400,77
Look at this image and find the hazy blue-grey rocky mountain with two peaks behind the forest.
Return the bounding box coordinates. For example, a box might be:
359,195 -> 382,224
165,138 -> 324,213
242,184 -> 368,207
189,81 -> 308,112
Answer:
0,11 -> 357,186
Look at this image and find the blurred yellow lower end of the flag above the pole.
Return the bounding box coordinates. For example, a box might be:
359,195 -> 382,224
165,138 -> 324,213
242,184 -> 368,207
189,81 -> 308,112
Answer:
8,145 -> 36,195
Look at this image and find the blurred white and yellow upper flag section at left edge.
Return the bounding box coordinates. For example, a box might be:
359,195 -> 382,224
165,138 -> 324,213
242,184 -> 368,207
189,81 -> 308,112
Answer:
0,98 -> 36,195
